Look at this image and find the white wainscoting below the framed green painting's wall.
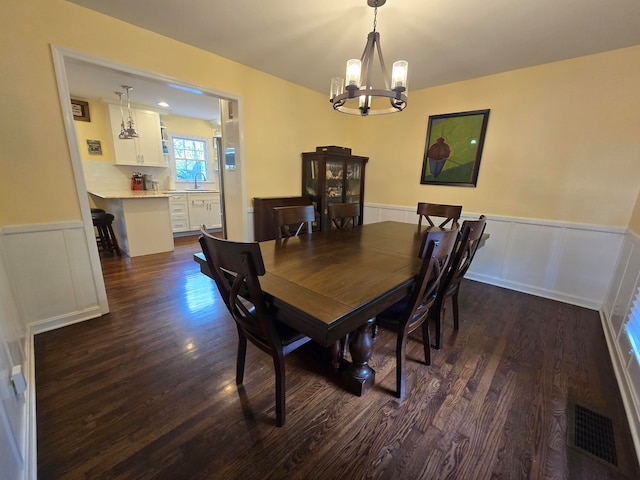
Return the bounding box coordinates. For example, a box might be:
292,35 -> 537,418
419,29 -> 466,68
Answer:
364,204 -> 625,310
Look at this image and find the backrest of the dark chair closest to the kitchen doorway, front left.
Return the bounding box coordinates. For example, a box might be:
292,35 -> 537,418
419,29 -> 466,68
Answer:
199,227 -> 280,353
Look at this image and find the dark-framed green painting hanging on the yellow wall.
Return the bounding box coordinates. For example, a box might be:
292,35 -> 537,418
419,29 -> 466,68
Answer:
420,109 -> 489,187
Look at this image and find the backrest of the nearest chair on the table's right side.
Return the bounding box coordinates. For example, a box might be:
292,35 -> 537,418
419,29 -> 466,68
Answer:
407,229 -> 458,331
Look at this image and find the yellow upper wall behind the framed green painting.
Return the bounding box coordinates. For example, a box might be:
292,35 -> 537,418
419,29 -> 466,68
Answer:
351,47 -> 640,227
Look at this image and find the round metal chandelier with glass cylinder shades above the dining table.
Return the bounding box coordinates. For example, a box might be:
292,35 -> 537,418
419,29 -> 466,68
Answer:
329,0 -> 409,116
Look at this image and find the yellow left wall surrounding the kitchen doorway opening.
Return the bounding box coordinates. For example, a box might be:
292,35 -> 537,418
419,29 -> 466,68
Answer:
0,0 -> 349,225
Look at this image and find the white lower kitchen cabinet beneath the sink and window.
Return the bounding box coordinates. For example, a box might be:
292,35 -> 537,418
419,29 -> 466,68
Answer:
169,193 -> 222,233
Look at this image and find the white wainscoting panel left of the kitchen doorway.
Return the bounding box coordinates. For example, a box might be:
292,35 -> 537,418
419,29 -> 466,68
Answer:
0,222 -> 103,333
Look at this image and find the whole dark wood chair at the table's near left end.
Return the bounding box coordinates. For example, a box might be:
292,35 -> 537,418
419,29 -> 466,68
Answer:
199,226 -> 310,427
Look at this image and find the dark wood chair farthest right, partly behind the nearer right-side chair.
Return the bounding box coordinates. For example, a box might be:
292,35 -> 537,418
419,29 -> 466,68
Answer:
430,215 -> 486,349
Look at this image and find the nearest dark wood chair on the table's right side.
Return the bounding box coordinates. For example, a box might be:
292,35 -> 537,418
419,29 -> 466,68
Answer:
376,230 -> 458,398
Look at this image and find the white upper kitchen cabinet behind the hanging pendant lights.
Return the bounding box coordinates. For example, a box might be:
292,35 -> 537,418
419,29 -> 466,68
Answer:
109,104 -> 167,167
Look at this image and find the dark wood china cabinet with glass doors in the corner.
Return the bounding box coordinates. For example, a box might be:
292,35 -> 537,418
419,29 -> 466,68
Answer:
302,146 -> 369,230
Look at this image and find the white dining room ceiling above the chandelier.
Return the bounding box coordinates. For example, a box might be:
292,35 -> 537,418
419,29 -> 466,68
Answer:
70,0 -> 640,118
